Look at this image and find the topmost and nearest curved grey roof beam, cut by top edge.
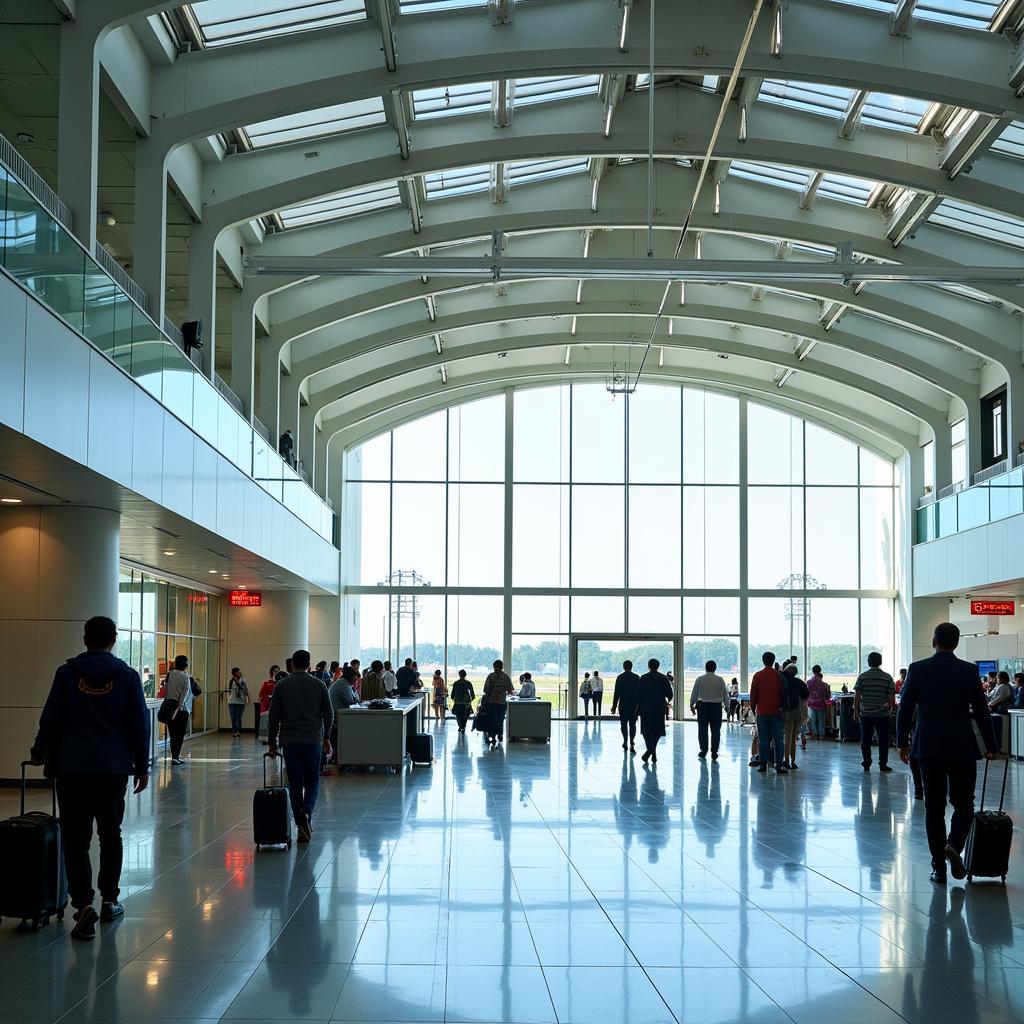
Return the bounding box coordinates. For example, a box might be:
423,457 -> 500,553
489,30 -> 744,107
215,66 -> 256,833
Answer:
148,0 -> 1024,148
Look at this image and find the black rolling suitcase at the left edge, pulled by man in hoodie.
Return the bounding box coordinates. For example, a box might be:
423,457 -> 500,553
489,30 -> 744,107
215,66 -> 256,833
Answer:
0,761 -> 68,931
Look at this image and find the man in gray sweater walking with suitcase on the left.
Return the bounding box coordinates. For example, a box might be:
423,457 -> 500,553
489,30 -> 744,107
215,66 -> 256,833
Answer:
267,650 -> 334,843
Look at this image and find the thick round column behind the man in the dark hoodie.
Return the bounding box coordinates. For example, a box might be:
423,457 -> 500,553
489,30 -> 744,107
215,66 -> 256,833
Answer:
0,505 -> 118,779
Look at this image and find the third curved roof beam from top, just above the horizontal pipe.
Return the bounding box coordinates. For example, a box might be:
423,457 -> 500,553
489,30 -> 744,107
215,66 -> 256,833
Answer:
246,164 -> 1024,306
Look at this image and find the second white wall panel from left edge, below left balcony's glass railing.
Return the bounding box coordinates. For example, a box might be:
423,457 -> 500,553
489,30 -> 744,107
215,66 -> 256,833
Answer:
25,302 -> 92,464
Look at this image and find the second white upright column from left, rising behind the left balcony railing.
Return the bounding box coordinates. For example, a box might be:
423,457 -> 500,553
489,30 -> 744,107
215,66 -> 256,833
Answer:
132,139 -> 168,326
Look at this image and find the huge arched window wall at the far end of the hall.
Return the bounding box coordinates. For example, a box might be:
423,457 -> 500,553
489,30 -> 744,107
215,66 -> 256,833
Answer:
344,383 -> 898,698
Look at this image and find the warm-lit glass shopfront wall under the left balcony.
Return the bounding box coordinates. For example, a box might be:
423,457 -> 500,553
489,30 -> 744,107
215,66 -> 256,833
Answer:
117,565 -> 222,732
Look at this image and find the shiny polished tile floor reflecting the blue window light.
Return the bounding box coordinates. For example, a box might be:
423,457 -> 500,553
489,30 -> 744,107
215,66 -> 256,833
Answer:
0,721 -> 1024,1024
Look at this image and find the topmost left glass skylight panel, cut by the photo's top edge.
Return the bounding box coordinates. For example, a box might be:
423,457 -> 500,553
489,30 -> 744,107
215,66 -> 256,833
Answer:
185,0 -> 367,46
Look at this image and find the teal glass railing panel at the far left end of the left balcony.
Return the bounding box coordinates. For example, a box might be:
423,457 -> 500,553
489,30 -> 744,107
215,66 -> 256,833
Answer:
3,174 -> 85,332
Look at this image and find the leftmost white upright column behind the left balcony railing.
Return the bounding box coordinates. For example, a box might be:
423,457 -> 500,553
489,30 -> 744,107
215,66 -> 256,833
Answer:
57,14 -> 105,253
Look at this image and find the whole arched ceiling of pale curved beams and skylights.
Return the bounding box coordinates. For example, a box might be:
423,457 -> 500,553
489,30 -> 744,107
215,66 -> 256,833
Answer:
110,0 -> 1024,489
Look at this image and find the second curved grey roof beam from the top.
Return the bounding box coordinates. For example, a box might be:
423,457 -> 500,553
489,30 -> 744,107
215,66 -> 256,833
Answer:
203,87 -> 1024,231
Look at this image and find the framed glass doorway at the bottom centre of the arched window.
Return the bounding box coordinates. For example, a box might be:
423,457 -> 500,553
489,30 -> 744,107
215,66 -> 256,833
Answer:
566,633 -> 685,718
